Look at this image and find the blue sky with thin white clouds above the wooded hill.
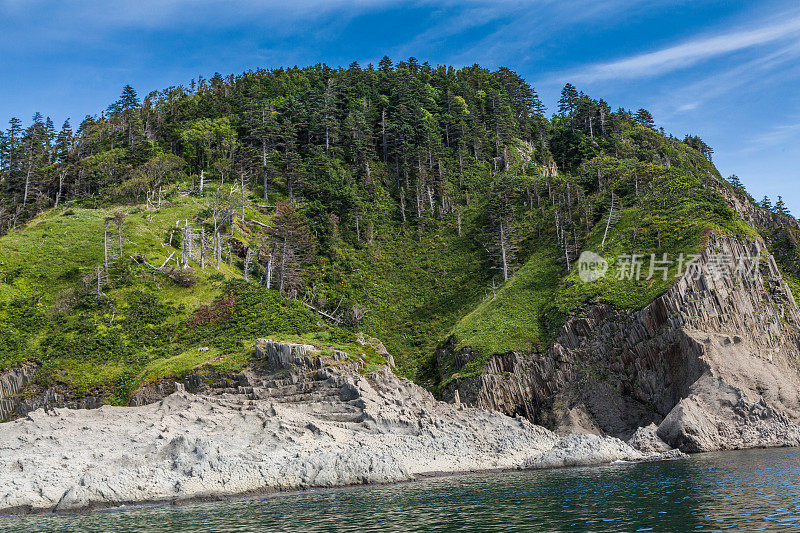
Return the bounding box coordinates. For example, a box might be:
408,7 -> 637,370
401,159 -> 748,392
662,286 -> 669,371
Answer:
0,0 -> 800,215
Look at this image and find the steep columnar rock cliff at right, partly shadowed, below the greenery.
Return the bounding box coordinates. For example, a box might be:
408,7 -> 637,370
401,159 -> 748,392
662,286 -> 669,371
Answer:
443,236 -> 800,451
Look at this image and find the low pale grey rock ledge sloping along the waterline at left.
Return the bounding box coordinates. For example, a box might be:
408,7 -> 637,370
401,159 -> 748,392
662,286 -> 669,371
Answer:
0,343 -> 680,513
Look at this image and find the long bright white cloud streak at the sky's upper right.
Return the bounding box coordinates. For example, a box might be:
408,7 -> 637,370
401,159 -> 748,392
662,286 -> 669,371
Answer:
572,12 -> 800,83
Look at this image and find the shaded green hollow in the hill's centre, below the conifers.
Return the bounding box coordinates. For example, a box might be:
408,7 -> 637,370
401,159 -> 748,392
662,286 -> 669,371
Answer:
331,221 -> 487,377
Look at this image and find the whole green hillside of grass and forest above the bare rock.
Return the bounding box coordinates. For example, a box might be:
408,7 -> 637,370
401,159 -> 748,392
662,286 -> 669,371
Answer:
0,59 -> 800,416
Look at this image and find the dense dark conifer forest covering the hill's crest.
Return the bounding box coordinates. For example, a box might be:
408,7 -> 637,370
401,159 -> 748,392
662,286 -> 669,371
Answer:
0,57 -> 744,254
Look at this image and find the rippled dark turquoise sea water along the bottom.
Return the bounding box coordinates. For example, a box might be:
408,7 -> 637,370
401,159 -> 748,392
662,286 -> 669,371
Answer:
0,449 -> 800,532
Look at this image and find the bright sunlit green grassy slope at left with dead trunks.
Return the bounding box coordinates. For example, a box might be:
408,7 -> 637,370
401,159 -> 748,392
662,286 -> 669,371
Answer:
0,189 -> 384,402
